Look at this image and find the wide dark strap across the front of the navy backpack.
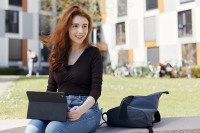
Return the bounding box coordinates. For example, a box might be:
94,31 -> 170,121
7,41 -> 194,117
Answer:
119,96 -> 134,120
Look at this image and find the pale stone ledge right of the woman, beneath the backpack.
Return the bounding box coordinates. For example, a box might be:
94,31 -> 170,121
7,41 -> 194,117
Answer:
95,116 -> 200,133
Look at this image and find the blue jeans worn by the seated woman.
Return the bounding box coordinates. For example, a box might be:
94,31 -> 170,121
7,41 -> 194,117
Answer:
25,95 -> 102,133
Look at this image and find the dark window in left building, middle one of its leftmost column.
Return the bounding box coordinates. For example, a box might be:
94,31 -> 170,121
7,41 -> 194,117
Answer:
5,10 -> 19,33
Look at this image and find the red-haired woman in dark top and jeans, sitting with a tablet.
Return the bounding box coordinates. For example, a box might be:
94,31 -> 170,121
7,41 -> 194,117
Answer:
26,6 -> 103,133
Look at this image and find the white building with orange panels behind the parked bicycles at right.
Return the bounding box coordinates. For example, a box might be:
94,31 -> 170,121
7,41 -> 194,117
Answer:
102,0 -> 200,67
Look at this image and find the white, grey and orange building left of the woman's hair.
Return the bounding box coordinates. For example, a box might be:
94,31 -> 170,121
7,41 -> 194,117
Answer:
0,0 -> 53,69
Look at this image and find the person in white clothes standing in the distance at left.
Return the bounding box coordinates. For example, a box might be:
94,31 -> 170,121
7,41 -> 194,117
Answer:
26,49 -> 36,77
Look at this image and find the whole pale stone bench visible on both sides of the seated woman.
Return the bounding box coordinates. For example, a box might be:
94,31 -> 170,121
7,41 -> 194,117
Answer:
0,116 -> 200,133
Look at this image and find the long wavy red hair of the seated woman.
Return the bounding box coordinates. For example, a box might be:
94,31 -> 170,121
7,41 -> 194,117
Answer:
41,5 -> 92,72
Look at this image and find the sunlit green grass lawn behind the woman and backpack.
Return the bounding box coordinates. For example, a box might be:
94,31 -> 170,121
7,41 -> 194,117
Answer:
0,75 -> 200,119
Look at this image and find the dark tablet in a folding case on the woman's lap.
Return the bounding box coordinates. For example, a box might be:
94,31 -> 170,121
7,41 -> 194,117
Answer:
26,91 -> 69,122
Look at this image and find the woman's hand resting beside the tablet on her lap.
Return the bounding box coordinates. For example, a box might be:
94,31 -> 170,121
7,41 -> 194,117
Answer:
67,106 -> 84,121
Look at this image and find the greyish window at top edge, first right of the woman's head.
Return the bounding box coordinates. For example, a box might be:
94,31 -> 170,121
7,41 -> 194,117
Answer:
117,0 -> 127,17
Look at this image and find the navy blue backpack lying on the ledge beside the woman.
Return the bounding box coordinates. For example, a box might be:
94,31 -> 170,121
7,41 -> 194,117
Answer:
102,91 -> 169,133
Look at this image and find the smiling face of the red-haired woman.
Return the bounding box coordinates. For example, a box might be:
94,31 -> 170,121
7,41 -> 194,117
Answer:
69,15 -> 89,45
